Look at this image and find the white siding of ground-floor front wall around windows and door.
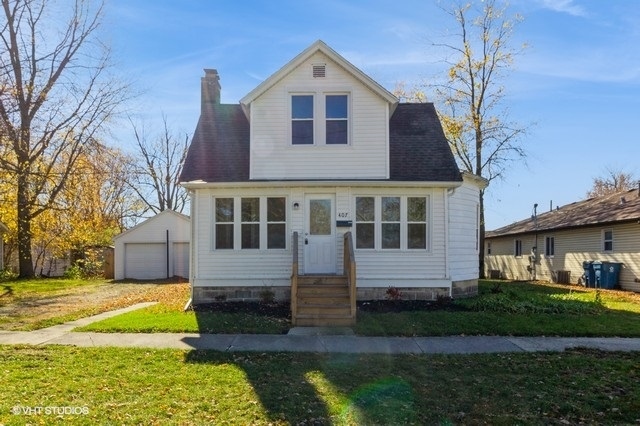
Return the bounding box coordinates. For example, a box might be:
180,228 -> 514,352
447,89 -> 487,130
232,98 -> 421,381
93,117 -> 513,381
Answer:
192,186 -> 456,287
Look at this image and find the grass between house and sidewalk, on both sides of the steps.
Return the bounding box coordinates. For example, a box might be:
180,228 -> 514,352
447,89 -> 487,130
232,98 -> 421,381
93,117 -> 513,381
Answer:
79,281 -> 640,337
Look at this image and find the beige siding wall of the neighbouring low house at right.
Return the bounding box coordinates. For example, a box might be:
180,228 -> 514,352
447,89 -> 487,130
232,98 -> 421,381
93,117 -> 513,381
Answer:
485,223 -> 640,291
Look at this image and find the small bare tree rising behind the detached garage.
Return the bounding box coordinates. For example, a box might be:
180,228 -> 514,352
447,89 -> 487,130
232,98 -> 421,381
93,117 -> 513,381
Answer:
130,116 -> 189,213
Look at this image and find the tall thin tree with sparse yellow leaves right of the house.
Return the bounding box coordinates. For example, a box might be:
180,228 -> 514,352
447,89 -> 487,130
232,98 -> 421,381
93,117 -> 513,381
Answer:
432,0 -> 526,277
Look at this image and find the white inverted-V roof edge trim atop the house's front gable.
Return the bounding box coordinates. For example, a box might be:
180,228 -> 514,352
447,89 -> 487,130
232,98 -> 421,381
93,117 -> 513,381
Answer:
240,40 -> 398,107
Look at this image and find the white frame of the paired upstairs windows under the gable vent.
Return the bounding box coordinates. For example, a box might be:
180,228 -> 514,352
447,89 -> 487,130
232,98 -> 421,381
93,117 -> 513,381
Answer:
287,89 -> 353,148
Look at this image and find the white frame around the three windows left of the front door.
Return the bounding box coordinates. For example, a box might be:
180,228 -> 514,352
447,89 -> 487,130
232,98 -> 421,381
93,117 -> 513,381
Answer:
210,194 -> 291,252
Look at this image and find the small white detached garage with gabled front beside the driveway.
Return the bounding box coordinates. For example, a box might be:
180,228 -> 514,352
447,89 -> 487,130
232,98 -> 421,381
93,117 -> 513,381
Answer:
114,210 -> 191,280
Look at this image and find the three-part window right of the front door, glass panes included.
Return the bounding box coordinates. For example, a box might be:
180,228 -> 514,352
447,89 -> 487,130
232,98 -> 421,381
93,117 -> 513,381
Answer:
355,196 -> 429,250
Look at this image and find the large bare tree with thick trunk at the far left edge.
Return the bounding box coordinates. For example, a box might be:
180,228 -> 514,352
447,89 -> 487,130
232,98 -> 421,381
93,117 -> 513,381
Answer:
0,0 -> 128,277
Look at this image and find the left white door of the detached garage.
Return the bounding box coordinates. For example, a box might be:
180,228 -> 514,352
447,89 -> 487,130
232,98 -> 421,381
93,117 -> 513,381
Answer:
124,243 -> 167,280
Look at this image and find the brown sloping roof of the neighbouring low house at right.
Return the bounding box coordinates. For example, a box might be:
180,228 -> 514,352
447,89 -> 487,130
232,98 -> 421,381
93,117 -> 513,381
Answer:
485,189 -> 640,238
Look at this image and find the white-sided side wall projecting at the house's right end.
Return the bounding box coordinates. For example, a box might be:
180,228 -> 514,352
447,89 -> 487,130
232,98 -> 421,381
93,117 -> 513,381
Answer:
448,178 -> 479,281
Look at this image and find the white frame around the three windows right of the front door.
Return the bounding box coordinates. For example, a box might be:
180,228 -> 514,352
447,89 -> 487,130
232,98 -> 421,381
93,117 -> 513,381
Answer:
352,194 -> 433,253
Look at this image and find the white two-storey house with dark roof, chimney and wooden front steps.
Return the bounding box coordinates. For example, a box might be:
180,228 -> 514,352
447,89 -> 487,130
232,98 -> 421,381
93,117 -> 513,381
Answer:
180,41 -> 486,324
